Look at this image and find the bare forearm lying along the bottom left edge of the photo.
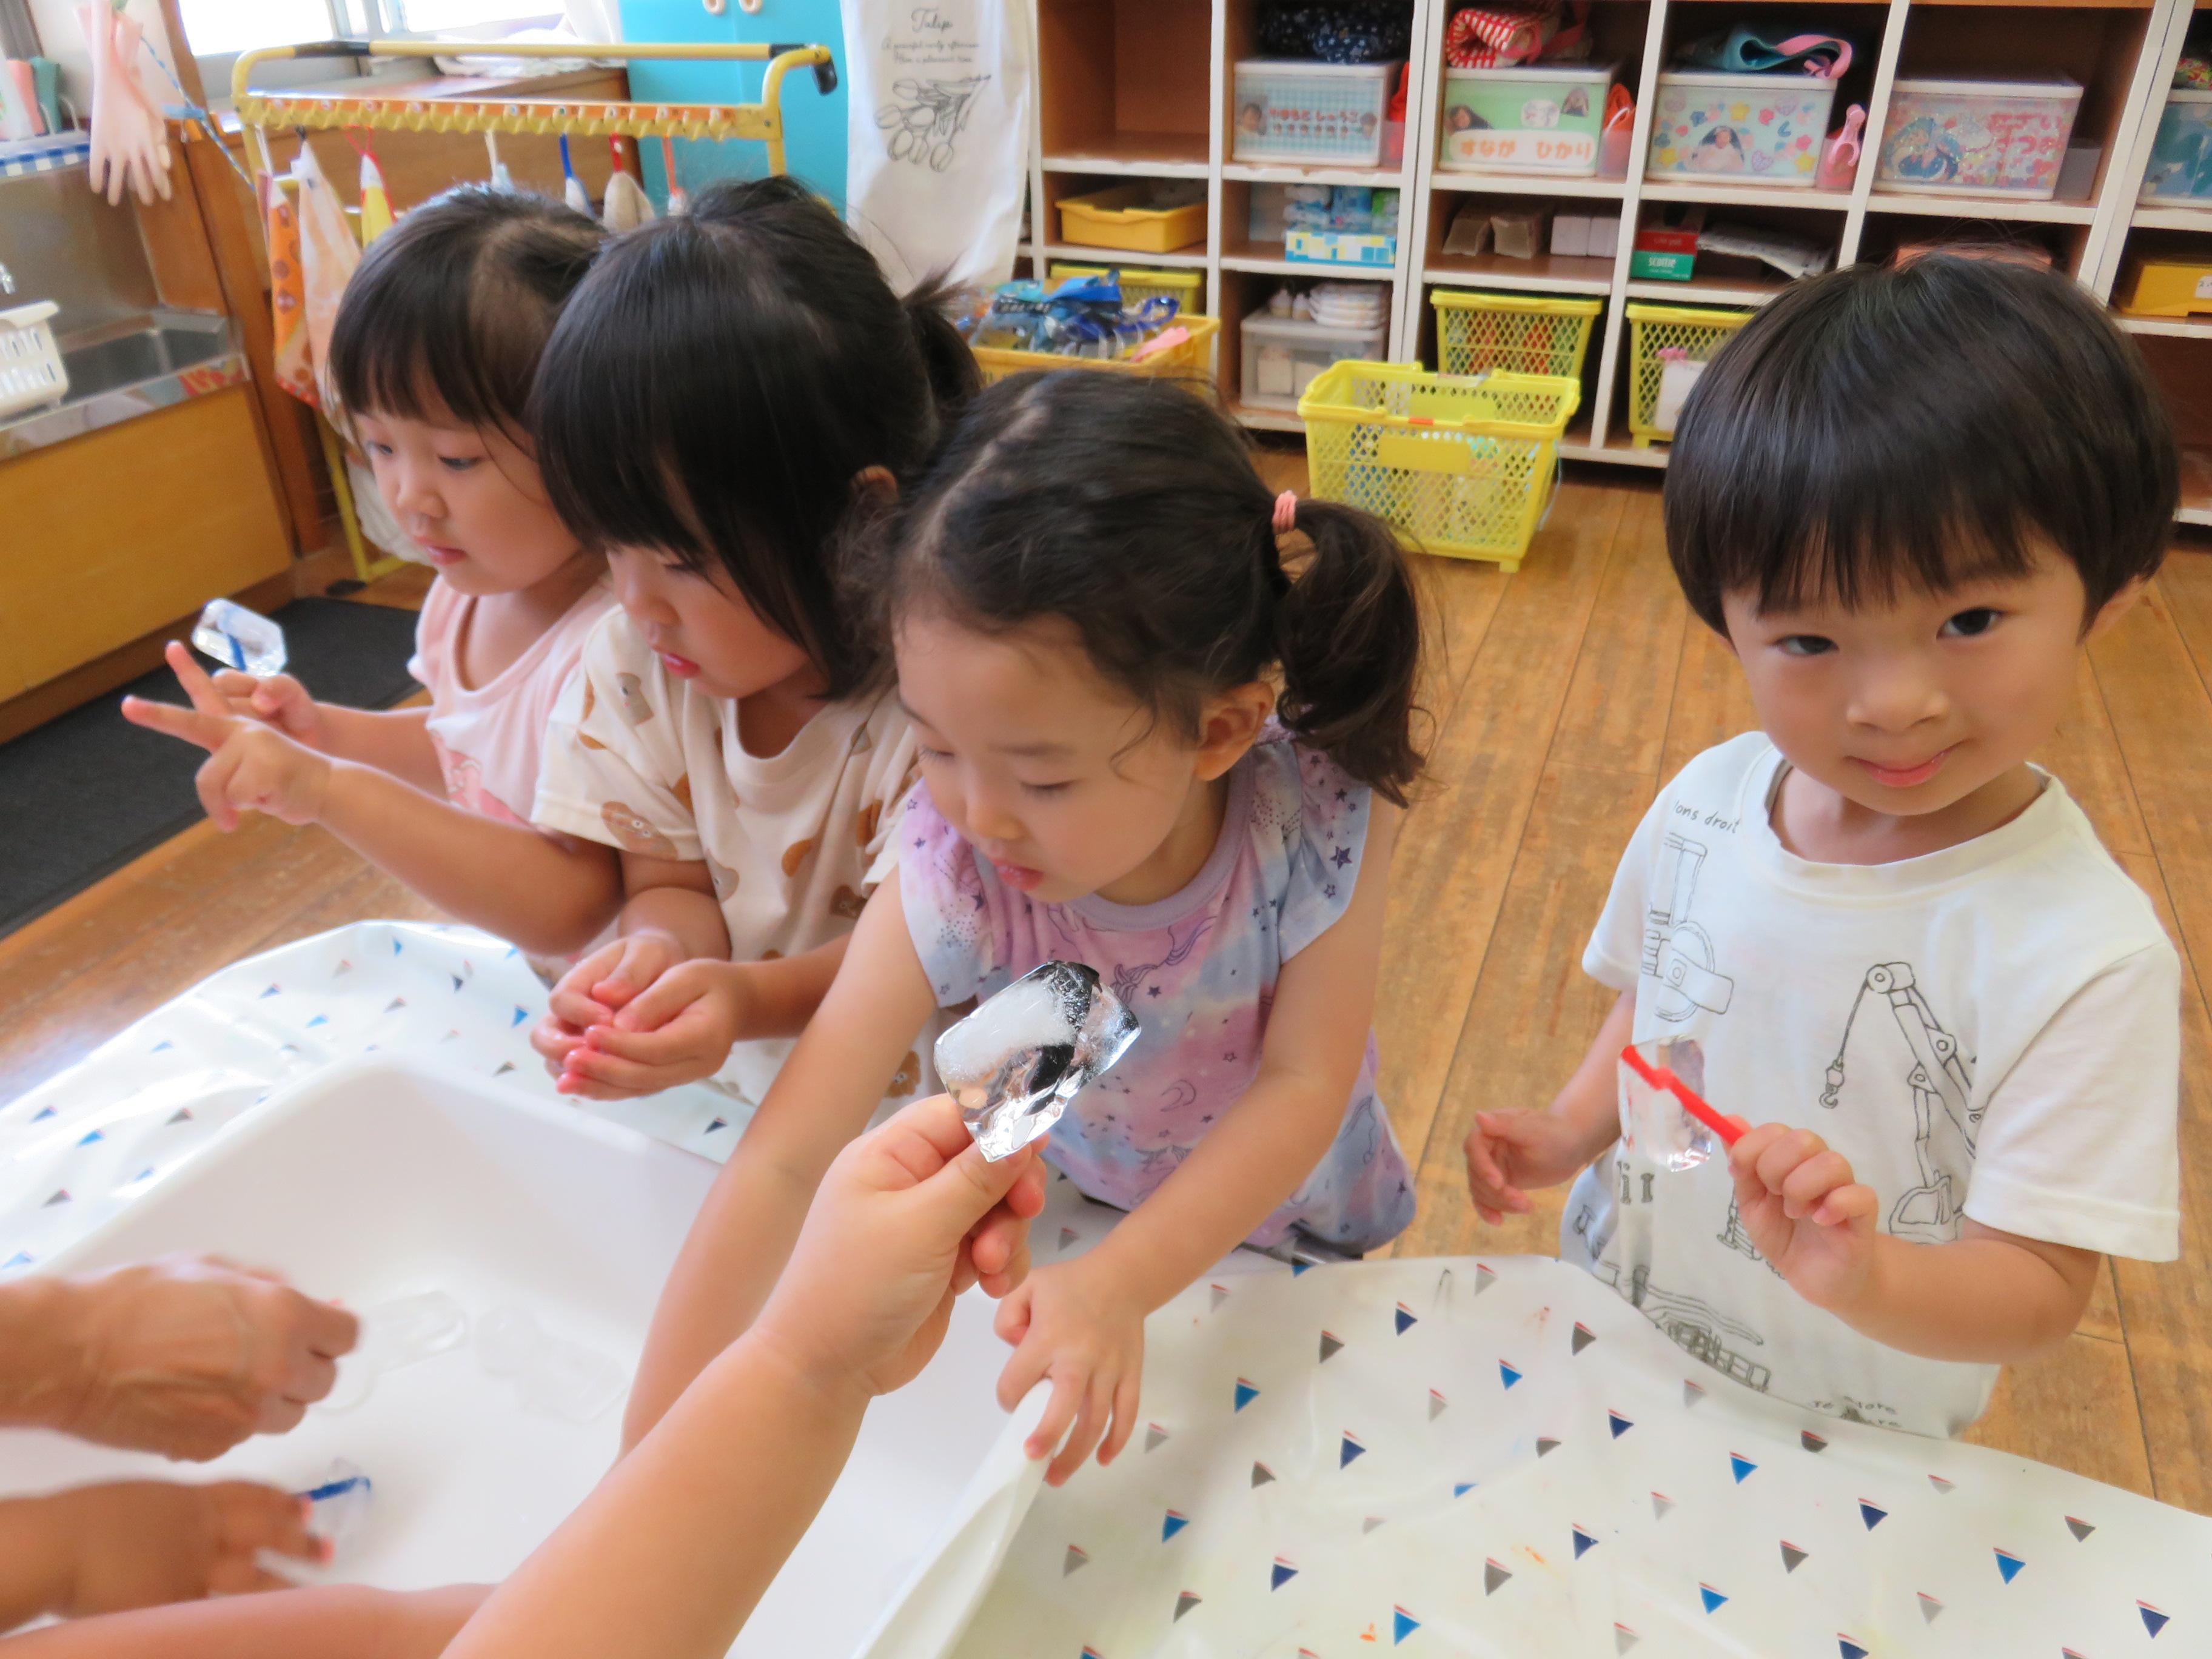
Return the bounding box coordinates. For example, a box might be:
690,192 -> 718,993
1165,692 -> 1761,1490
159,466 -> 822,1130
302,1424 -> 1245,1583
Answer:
0,1584 -> 491,1659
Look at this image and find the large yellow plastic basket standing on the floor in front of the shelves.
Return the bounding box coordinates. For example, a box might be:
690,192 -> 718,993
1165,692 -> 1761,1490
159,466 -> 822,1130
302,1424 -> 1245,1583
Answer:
1298,358 -> 1581,573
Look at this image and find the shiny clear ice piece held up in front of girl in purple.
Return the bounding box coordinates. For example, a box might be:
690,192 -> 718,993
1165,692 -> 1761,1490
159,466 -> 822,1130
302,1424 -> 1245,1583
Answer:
938,962 -> 1137,1164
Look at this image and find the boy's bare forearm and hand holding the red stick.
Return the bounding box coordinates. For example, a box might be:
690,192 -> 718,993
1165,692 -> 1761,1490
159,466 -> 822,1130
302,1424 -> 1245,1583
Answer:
1730,1124 -> 2102,1365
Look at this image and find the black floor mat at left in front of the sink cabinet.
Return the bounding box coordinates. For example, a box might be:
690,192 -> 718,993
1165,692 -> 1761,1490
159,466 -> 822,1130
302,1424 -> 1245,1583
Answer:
0,600 -> 416,933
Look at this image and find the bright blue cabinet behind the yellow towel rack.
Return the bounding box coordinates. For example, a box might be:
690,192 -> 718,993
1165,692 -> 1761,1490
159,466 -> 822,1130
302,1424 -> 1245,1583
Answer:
622,0 -> 845,212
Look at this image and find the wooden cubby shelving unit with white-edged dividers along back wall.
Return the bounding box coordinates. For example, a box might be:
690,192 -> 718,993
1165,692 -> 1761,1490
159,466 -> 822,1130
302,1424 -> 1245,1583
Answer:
1022,0 -> 2212,525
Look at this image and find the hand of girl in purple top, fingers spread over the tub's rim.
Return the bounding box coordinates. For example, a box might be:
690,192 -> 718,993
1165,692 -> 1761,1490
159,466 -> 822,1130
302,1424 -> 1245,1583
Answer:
997,1259 -> 1146,1486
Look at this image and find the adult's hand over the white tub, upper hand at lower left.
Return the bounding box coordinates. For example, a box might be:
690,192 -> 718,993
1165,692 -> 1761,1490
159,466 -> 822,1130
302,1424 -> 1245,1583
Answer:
49,1256 -> 361,1462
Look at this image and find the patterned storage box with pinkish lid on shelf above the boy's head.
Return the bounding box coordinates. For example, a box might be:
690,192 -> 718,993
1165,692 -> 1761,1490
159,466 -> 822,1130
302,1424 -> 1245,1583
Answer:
1874,75 -> 2082,201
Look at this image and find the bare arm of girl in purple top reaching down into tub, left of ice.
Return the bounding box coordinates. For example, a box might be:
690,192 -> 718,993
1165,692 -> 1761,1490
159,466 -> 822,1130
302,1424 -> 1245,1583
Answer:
622,876 -> 936,1447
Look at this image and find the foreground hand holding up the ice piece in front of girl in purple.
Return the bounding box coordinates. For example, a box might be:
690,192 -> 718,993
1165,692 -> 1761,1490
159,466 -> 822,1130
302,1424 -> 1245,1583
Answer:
743,1095 -> 1044,1396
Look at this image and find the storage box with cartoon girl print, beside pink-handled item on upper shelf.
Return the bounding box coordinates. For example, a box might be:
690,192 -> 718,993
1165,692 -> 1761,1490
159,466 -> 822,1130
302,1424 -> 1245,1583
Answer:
1643,69 -> 1836,186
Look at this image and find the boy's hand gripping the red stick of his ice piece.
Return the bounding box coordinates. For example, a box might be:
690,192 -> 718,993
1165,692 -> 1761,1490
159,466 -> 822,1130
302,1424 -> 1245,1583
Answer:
1728,1124 -> 1880,1312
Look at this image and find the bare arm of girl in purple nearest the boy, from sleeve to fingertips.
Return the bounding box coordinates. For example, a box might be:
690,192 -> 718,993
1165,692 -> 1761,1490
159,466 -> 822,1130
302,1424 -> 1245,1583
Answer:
997,805 -> 1396,1484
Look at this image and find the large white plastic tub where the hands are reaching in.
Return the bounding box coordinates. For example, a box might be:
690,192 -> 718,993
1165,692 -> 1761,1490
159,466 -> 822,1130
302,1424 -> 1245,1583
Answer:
0,1064 -> 1007,1659
